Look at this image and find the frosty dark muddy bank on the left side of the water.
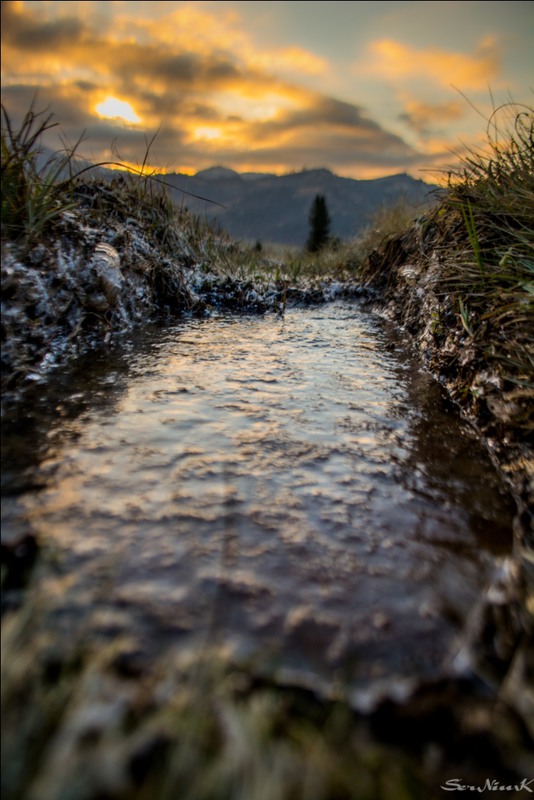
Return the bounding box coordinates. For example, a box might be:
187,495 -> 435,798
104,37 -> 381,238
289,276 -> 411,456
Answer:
1,180 -> 361,396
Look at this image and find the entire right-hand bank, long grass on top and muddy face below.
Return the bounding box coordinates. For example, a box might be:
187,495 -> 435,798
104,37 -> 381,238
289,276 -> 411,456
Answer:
360,107 -> 534,506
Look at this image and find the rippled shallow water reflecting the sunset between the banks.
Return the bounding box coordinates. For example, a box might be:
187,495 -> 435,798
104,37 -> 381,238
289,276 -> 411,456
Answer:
3,304 -> 513,704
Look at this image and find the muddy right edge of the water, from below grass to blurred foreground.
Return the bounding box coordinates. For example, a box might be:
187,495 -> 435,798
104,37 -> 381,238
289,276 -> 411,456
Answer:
366,214 -> 534,752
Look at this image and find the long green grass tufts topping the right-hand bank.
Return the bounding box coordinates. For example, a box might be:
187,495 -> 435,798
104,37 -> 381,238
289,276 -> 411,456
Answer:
360,105 -> 534,400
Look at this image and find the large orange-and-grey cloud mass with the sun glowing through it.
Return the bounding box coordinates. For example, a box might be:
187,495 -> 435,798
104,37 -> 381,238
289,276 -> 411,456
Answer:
3,2 -> 432,175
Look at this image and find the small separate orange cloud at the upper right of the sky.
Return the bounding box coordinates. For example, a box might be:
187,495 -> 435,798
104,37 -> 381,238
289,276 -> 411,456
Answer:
369,38 -> 500,91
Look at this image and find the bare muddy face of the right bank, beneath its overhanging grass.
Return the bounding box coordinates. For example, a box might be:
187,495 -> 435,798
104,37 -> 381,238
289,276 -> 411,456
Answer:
366,214 -> 534,548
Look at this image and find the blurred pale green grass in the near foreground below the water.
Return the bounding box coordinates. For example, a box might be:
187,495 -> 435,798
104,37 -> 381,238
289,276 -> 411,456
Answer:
2,609 -> 494,800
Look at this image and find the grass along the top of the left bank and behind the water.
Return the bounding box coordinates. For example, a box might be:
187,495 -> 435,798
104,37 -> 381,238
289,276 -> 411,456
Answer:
2,99 -> 422,312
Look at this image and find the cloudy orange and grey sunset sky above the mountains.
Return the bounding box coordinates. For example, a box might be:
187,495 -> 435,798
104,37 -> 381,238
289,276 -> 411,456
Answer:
2,0 -> 534,182
